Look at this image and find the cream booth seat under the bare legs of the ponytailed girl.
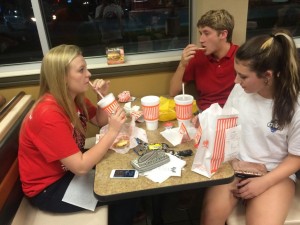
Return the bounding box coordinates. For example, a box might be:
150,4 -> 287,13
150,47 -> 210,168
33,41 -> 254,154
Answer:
226,179 -> 300,225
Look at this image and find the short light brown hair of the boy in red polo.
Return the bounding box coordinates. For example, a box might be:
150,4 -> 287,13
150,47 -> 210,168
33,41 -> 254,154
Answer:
197,9 -> 234,42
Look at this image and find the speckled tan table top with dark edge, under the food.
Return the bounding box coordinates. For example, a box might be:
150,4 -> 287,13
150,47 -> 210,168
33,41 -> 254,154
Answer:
94,121 -> 234,202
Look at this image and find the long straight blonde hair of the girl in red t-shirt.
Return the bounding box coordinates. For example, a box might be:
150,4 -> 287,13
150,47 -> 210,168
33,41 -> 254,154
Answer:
39,45 -> 88,135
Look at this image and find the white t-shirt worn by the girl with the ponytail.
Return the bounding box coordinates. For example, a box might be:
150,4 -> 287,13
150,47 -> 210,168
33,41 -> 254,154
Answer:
224,84 -> 300,179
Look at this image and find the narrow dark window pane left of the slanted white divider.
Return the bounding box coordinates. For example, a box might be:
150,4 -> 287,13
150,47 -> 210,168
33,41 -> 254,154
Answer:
0,0 -> 43,65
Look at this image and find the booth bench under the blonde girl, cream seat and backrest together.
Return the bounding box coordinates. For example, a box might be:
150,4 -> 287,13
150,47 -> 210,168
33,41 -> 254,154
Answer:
0,95 -> 108,225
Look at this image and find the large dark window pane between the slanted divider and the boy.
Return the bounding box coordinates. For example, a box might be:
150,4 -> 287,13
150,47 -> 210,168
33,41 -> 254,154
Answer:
42,0 -> 189,56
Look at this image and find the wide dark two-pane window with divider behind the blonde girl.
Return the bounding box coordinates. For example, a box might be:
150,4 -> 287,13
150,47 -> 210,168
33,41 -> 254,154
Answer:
0,0 -> 190,65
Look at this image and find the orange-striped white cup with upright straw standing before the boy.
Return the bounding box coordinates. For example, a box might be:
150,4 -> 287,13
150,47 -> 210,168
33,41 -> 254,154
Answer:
174,94 -> 194,127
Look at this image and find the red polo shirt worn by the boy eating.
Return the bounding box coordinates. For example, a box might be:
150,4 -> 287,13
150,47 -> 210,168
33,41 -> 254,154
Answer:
183,44 -> 238,110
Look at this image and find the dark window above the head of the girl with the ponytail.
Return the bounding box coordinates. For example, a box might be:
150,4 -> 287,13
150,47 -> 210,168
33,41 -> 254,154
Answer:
247,0 -> 300,39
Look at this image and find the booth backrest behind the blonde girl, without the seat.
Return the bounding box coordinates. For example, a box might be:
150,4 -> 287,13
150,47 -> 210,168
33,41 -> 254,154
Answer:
0,92 -> 34,225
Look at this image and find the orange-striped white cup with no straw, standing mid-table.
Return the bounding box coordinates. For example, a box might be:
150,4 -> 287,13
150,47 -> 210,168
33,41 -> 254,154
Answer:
141,95 -> 159,130
